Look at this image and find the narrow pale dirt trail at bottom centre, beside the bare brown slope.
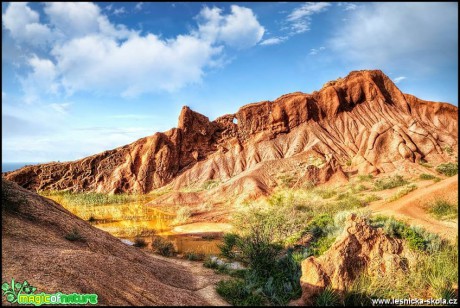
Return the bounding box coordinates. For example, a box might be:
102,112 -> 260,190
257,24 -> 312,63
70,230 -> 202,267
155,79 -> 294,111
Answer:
149,253 -> 230,306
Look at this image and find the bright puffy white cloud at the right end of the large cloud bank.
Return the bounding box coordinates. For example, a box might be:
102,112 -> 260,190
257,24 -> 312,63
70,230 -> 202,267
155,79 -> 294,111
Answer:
198,5 -> 265,49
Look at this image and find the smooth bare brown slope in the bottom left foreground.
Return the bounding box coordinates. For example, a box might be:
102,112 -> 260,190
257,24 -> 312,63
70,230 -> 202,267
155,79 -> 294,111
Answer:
2,180 -> 219,306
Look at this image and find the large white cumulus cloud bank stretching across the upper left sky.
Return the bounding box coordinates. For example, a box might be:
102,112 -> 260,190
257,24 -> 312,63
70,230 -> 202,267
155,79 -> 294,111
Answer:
3,2 -> 265,98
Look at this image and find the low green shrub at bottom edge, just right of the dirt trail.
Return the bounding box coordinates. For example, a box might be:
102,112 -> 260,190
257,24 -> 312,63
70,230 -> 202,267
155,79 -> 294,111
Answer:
216,279 -> 264,306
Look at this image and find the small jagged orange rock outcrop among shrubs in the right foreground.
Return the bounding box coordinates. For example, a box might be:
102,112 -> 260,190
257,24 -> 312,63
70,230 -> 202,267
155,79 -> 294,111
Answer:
300,214 -> 411,304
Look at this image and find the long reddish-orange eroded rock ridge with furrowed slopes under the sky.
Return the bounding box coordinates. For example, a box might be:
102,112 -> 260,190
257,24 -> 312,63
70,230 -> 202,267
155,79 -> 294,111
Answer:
2,70 -> 458,193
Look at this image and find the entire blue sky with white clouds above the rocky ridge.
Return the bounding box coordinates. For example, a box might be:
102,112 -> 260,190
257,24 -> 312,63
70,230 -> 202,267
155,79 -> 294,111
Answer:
2,2 -> 458,162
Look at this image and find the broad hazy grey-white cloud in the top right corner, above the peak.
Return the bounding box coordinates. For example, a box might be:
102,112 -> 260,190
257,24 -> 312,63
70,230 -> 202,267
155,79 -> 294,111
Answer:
329,2 -> 458,71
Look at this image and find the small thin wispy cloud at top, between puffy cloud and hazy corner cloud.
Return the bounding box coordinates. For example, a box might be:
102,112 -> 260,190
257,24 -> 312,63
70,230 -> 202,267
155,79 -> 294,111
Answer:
287,2 -> 331,34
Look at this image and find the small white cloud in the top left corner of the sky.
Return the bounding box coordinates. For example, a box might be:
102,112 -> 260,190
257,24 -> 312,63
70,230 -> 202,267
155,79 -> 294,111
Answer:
2,2 -> 51,45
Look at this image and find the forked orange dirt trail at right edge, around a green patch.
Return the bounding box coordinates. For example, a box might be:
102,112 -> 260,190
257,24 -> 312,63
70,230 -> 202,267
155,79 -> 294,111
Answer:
369,176 -> 458,240
